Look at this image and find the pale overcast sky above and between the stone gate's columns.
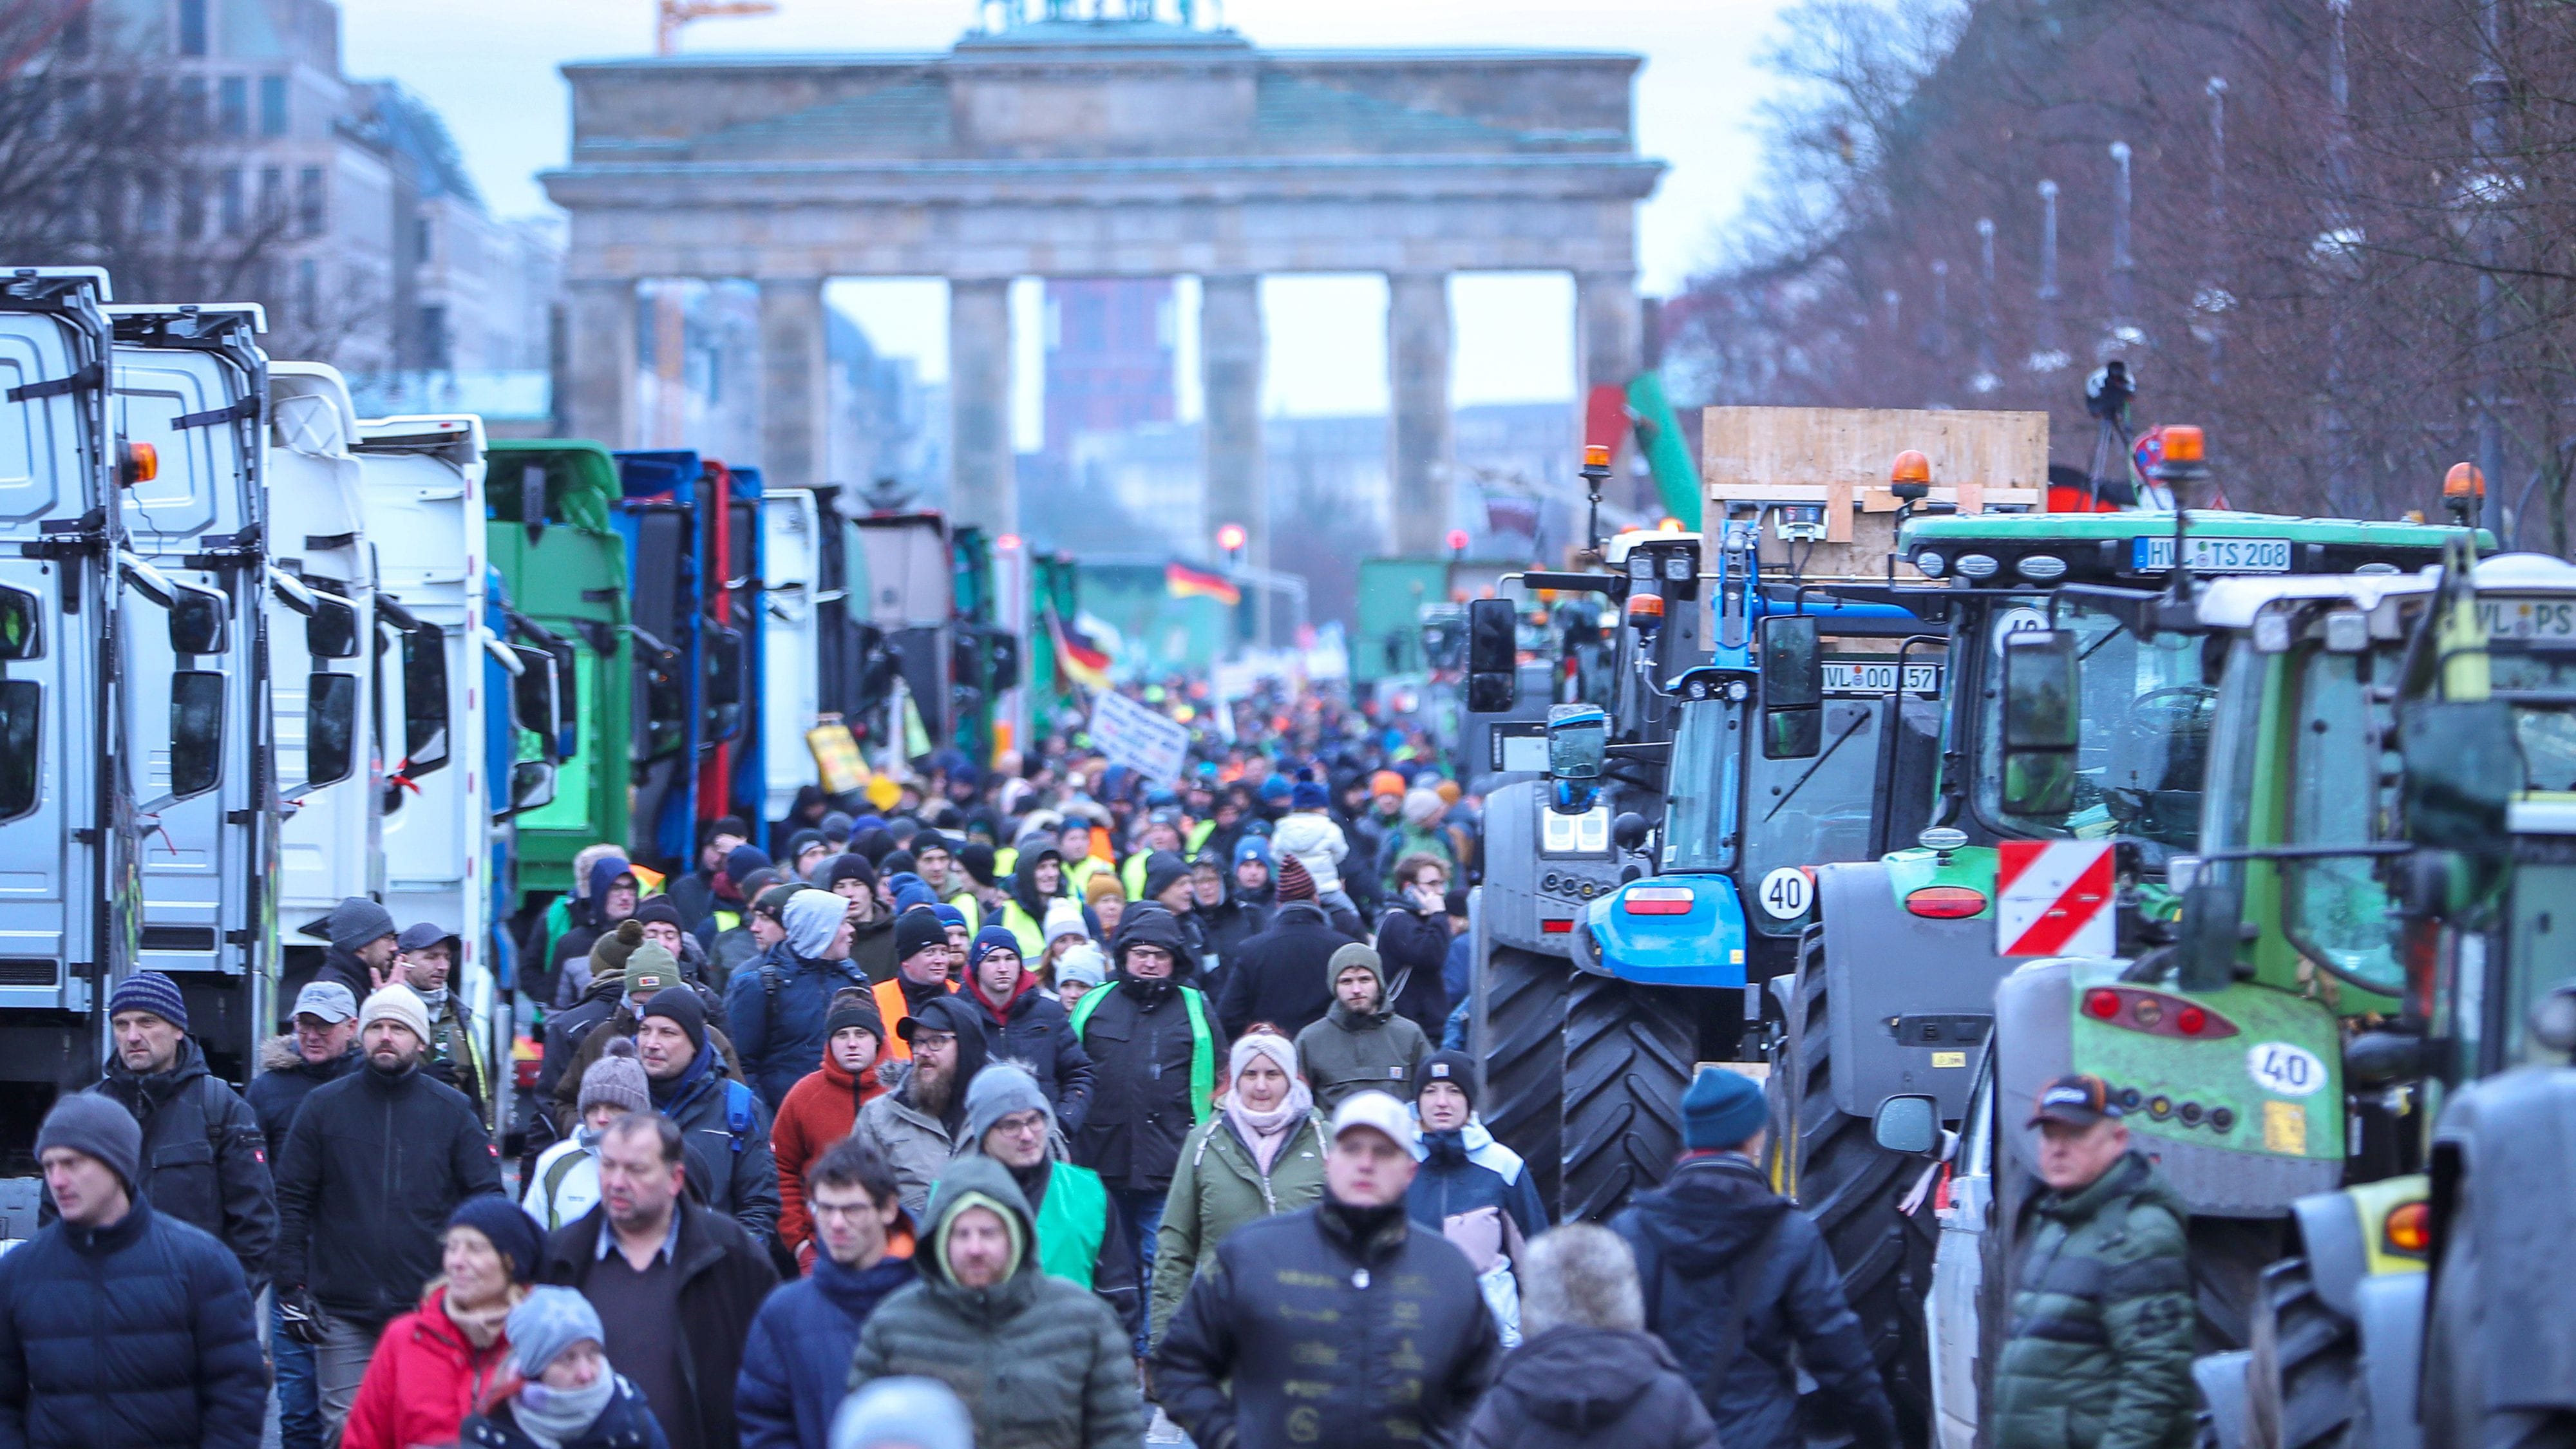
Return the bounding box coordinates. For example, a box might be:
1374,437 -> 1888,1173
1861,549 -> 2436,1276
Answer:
343,0 -> 1780,415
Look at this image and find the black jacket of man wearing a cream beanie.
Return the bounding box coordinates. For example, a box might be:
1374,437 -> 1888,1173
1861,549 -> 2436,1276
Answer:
276,1067 -> 502,1325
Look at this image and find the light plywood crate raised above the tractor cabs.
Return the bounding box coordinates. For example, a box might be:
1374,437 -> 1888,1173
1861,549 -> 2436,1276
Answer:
1700,408 -> 2048,578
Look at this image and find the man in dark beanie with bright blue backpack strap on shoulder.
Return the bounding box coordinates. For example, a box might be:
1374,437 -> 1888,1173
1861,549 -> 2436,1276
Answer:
636,990 -> 778,1243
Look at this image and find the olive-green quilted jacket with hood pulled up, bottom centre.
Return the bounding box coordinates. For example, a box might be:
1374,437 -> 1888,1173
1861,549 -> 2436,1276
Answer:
850,1158 -> 1144,1449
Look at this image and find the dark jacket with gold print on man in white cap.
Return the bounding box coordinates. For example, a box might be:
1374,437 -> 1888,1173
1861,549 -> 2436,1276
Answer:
1154,1197 -> 1502,1449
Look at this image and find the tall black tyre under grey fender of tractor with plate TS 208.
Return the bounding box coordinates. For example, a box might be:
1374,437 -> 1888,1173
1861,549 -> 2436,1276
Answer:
1770,923 -> 1940,1444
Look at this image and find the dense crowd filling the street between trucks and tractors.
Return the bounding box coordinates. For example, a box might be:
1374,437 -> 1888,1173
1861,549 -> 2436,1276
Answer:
0,685 -> 2195,1449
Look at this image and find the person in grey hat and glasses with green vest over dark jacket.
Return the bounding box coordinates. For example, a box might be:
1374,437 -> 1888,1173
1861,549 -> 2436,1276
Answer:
953,1062 -> 1144,1336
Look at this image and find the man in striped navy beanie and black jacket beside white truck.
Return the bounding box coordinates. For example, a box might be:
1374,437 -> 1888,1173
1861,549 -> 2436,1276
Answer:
90,972 -> 278,1292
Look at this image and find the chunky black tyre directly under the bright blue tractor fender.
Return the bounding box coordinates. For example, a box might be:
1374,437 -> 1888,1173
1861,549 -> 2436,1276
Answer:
1556,972 -> 1698,1222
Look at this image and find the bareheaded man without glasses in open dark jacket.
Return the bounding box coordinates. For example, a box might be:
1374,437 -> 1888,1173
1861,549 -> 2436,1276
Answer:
546,1112 -> 778,1449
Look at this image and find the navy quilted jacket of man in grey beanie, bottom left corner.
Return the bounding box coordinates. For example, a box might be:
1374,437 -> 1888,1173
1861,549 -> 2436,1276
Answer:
0,1199 -> 268,1449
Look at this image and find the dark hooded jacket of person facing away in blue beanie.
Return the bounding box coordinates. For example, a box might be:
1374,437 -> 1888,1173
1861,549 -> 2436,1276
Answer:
1610,1153 -> 1896,1449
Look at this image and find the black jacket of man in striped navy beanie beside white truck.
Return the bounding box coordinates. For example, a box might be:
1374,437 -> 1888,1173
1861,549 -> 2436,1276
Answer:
84,1036 -> 278,1292
